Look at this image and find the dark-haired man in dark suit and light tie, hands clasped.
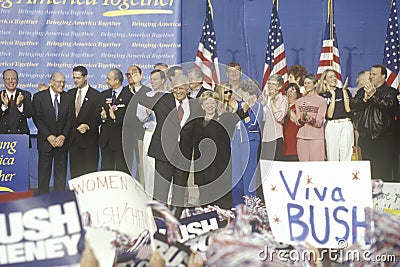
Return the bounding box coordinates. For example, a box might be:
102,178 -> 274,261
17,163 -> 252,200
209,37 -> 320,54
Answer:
68,66 -> 100,178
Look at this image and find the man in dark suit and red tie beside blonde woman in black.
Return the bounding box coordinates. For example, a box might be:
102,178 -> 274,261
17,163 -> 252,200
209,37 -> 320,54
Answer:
140,75 -> 196,217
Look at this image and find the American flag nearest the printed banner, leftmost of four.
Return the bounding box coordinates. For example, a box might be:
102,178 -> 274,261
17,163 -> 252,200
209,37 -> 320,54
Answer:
195,0 -> 220,89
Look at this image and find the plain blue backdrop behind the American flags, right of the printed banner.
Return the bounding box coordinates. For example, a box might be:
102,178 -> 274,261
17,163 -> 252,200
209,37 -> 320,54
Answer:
182,0 -> 391,86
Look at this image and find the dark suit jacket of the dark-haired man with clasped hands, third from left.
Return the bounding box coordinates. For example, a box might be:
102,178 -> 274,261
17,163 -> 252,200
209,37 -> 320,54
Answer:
68,86 -> 101,148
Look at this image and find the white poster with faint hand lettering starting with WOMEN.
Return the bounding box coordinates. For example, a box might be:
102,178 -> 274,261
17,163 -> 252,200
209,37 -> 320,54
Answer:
69,171 -> 155,237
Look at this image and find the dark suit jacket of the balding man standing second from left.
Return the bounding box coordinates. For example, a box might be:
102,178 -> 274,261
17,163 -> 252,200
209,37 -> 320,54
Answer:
33,88 -> 74,152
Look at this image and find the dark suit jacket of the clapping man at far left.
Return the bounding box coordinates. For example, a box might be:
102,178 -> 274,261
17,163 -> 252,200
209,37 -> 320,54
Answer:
0,88 -> 33,134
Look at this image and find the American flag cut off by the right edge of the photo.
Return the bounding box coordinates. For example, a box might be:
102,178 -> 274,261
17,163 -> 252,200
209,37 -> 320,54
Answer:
383,0 -> 400,89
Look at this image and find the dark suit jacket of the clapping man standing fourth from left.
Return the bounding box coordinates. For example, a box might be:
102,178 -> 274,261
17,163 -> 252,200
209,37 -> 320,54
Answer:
99,87 -> 132,151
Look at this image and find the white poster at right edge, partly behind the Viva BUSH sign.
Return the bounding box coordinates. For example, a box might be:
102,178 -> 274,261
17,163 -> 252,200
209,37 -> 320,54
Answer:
374,183 -> 400,213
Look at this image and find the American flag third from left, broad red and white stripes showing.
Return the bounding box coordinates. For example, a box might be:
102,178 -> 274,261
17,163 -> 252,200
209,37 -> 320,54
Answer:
317,0 -> 342,88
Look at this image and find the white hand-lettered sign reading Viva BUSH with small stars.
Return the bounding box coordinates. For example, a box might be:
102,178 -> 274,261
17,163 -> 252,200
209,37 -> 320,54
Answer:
261,160 -> 372,248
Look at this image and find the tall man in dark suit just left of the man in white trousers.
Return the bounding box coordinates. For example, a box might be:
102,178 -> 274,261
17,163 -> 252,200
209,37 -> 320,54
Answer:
124,65 -> 151,182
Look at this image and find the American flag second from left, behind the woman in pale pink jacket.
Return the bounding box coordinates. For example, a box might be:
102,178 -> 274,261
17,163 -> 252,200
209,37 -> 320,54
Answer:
262,2 -> 288,90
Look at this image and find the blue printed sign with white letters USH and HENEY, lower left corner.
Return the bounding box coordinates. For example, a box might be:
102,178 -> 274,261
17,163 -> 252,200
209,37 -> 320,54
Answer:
0,192 -> 84,267
